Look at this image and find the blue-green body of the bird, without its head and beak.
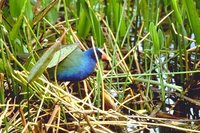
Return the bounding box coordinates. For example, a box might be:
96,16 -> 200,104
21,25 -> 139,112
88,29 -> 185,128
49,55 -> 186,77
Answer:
57,49 -> 96,81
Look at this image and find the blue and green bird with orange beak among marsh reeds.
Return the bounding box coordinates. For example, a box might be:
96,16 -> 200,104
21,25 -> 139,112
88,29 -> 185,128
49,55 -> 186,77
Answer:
48,47 -> 110,82
